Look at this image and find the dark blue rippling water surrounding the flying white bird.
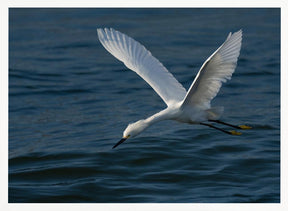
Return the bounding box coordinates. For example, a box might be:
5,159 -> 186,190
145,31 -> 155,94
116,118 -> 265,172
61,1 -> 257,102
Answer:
9,9 -> 280,203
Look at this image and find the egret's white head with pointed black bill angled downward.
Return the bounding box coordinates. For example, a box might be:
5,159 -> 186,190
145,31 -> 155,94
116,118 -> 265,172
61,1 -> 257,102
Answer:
113,120 -> 148,148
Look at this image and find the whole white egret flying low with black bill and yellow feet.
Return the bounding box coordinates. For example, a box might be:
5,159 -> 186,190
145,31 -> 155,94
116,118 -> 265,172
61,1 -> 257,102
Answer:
97,28 -> 251,148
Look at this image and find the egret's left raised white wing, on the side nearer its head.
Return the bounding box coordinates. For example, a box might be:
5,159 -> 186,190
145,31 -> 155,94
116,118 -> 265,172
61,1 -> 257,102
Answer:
97,28 -> 186,106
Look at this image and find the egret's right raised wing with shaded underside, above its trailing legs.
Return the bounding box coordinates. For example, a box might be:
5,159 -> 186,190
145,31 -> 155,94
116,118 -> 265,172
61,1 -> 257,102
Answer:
182,30 -> 242,109
